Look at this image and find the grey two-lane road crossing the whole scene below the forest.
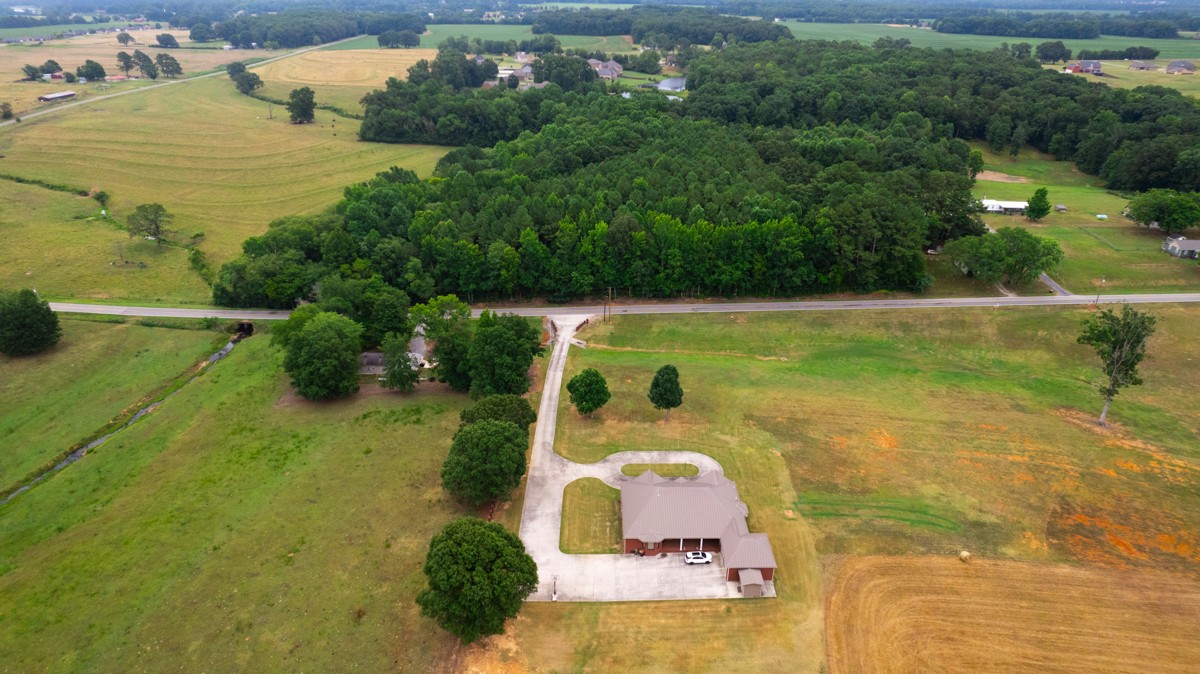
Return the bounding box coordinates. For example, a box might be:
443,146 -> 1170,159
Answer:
50,293 -> 1200,320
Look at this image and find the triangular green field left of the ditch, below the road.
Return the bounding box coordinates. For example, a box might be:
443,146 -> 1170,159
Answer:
0,320 -> 227,489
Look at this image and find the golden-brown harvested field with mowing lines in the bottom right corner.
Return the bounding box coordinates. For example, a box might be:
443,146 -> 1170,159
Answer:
826,556 -> 1200,674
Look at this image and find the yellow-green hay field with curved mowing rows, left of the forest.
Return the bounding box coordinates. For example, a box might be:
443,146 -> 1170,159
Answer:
0,73 -> 446,301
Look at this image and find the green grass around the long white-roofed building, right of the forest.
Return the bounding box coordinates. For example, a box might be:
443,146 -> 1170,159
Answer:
969,144 -> 1200,294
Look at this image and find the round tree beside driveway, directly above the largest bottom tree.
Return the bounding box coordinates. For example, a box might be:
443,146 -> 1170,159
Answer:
442,419 -> 529,506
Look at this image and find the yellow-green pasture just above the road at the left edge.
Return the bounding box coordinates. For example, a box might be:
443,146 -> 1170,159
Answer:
0,179 -> 211,303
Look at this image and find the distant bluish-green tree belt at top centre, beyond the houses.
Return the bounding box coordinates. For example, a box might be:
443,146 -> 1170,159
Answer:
533,6 -> 792,48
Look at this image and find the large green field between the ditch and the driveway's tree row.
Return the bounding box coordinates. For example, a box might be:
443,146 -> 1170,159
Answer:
0,328 -> 469,672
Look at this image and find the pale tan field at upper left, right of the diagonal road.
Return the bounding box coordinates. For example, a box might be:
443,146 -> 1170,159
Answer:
254,49 -> 438,113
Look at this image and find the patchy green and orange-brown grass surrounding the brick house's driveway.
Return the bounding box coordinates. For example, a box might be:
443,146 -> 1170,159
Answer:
467,306 -> 1200,672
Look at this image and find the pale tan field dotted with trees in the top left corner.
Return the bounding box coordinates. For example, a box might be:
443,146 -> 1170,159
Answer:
0,30 -> 258,115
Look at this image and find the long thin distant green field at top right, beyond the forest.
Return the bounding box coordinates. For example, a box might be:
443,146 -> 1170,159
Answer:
785,20 -> 1200,59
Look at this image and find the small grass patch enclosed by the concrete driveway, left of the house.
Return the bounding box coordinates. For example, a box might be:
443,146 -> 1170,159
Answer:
558,477 -> 620,554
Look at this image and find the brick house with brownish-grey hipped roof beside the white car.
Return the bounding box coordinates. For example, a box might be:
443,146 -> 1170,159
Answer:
620,470 -> 775,585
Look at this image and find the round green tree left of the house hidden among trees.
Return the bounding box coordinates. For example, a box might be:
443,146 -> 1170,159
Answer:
283,312 -> 362,401
